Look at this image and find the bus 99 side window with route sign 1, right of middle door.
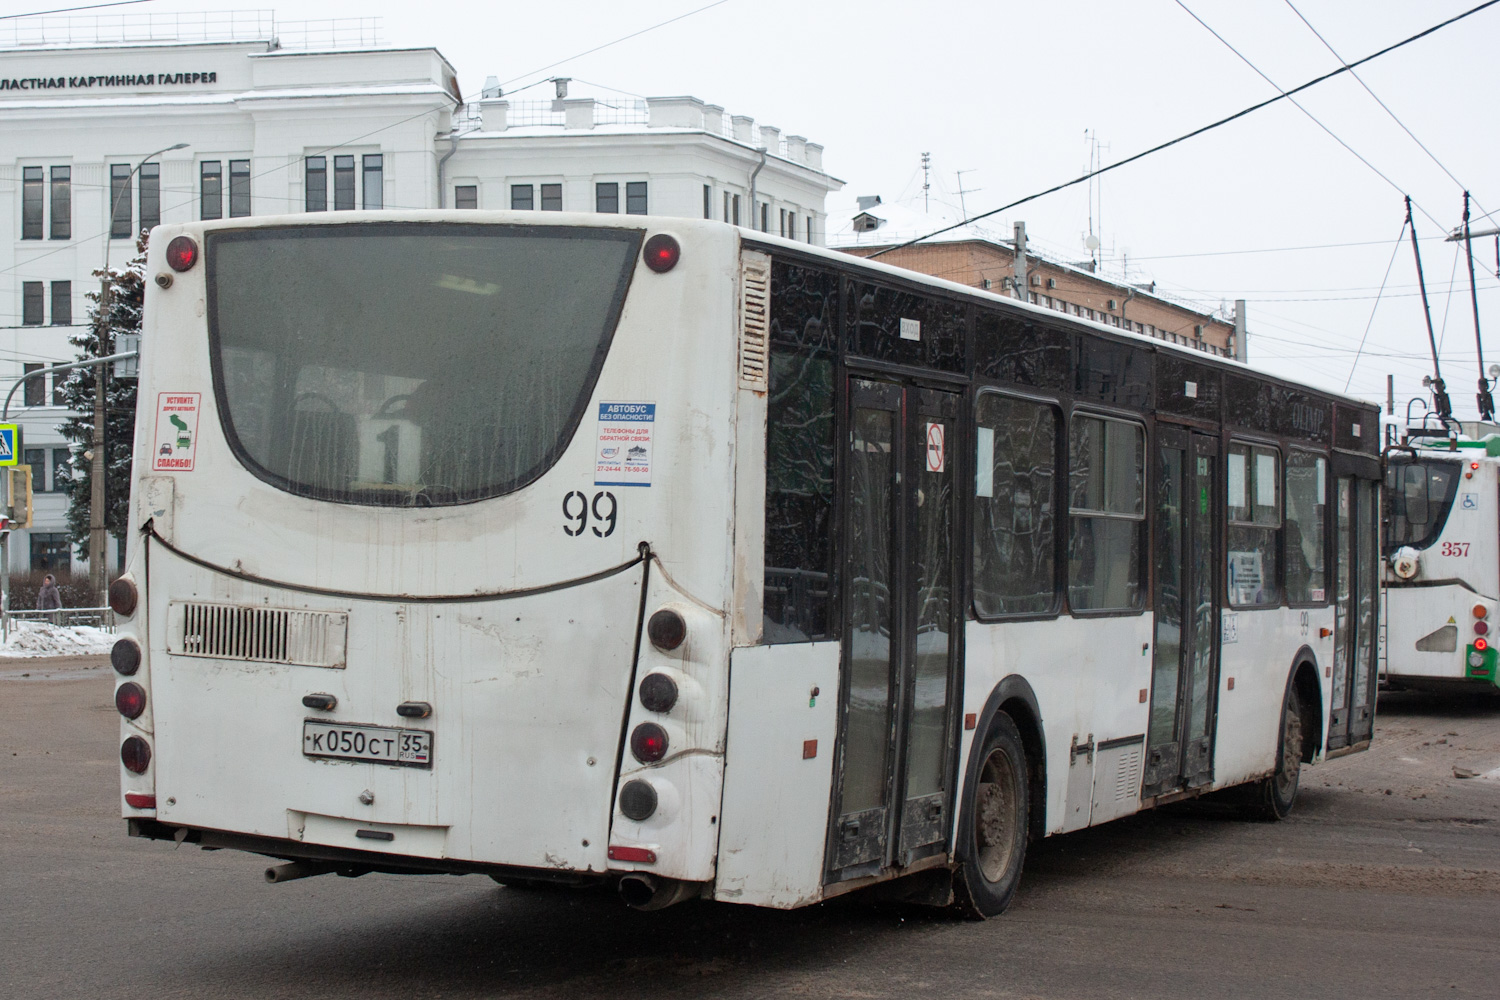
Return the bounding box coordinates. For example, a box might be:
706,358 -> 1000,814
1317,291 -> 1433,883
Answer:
1226,444 -> 1281,606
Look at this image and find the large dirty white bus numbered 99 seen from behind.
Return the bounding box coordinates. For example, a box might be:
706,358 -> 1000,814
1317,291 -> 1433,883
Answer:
111,211 -> 1380,915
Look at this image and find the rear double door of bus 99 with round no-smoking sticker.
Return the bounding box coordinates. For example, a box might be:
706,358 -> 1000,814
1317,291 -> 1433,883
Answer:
828,378 -> 959,880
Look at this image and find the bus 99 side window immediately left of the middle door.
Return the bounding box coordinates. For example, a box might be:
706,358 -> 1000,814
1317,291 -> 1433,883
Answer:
1068,415 -> 1146,612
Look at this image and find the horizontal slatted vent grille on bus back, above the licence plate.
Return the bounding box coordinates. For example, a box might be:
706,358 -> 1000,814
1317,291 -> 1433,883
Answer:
167,601 -> 350,669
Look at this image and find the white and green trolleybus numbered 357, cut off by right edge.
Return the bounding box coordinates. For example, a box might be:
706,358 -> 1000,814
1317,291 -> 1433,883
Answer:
1380,426 -> 1500,694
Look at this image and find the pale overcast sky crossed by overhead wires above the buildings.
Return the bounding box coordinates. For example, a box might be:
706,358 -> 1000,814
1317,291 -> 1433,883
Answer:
17,0 -> 1500,418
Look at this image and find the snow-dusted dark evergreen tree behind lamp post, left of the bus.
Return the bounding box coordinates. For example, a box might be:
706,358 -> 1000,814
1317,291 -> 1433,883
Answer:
59,232 -> 146,558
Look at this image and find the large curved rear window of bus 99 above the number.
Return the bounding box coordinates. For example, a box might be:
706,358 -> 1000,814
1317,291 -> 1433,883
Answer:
204,223 -> 641,505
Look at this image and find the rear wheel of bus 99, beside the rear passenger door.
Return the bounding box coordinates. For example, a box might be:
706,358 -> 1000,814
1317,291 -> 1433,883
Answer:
954,712 -> 1031,921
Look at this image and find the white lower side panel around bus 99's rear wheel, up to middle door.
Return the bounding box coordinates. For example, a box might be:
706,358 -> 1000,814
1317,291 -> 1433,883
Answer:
954,615 -> 1152,834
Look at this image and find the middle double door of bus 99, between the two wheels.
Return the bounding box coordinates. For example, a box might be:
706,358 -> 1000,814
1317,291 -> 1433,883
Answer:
1142,424 -> 1220,798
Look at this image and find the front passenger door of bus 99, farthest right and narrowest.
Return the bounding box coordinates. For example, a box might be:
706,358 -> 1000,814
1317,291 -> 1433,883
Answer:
1328,475 -> 1380,750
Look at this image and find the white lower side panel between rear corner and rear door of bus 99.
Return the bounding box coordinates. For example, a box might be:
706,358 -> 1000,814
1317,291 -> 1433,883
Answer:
714,642 -> 840,909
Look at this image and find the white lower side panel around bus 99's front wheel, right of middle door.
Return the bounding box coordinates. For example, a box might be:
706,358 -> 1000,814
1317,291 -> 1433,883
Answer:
1214,607 -> 1334,789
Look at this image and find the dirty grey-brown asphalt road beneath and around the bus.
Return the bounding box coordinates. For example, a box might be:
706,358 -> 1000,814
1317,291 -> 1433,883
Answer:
0,661 -> 1500,1000
